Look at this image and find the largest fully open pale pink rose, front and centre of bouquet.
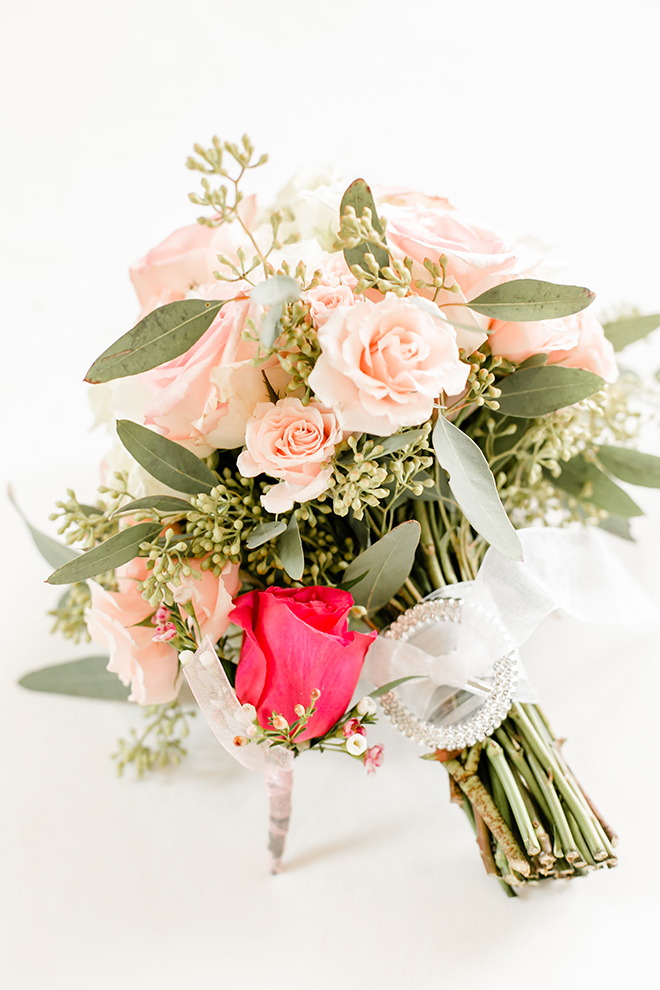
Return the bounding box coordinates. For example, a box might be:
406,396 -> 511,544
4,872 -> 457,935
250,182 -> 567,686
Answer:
309,293 -> 470,435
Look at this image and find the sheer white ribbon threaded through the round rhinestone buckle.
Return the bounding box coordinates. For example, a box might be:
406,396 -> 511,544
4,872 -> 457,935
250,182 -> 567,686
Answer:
363,526 -> 658,701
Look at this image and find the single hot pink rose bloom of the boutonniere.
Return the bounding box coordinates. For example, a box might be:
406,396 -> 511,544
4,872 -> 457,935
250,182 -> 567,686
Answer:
231,586 -> 376,740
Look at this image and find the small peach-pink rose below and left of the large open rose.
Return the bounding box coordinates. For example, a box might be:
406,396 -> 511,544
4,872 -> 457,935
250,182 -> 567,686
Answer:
237,398 -> 342,513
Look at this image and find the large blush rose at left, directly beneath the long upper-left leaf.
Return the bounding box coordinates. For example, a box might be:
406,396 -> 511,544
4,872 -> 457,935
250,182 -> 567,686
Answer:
140,299 -> 268,457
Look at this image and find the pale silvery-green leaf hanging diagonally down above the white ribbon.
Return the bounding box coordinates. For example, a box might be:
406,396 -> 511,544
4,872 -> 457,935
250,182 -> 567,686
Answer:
433,415 -> 522,560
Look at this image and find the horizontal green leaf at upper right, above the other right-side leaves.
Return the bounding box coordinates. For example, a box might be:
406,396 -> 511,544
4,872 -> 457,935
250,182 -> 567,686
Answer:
467,278 -> 596,323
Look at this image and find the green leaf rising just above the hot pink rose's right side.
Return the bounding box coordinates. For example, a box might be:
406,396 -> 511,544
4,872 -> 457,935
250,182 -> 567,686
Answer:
343,519 -> 421,613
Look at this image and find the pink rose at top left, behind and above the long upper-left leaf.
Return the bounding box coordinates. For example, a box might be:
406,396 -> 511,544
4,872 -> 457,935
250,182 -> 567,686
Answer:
130,202 -> 256,316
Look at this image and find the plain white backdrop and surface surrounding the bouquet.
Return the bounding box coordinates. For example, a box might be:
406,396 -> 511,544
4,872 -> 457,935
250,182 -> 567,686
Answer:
0,0 -> 660,990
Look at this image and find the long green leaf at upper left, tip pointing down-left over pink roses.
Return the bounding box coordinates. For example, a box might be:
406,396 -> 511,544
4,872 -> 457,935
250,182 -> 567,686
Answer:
85,299 -> 224,385
